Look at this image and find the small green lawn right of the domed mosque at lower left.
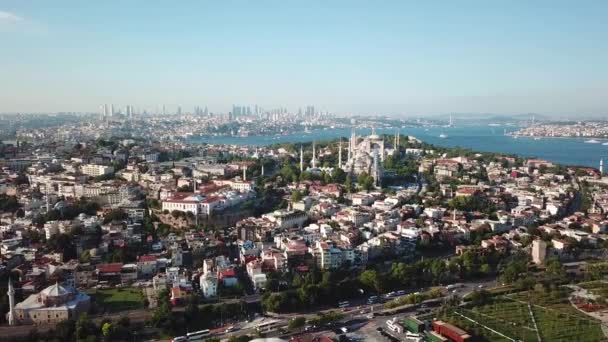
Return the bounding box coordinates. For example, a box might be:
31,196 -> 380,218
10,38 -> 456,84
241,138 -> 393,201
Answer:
88,287 -> 145,312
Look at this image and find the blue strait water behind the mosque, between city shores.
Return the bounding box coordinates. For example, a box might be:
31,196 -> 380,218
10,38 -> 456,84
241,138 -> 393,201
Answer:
189,125 -> 608,167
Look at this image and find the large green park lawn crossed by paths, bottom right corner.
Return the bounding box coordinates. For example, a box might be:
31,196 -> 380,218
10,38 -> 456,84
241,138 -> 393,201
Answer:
442,291 -> 606,342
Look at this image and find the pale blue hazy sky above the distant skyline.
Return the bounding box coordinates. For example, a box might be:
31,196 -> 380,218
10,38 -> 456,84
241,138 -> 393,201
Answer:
0,0 -> 608,117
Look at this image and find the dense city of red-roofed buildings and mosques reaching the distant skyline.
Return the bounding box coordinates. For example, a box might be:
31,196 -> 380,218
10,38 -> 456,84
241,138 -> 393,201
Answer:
0,111 -> 608,341
